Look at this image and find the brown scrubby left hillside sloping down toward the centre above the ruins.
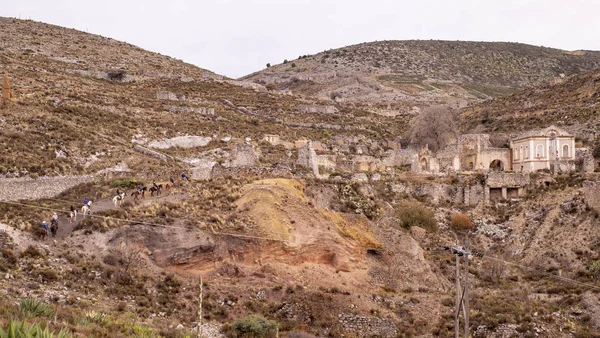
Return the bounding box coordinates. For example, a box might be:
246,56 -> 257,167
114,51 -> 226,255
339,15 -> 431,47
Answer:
0,18 -> 403,177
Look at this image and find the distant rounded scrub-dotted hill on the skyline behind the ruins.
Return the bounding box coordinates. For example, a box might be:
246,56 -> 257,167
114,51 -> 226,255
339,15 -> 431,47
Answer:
242,40 -> 600,113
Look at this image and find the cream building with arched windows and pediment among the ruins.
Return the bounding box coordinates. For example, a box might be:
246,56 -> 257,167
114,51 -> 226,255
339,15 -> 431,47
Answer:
510,126 -> 575,172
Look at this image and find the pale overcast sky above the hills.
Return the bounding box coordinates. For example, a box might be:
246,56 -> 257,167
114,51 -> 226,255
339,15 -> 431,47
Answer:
0,0 -> 600,78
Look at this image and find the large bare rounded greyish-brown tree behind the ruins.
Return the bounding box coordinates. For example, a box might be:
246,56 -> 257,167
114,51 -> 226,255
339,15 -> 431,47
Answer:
409,106 -> 456,151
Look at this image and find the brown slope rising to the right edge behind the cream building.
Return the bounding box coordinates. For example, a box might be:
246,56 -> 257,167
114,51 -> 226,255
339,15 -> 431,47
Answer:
462,65 -> 600,140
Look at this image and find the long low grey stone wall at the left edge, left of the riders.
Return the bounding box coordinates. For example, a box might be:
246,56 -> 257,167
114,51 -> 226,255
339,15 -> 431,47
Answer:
0,176 -> 93,201
